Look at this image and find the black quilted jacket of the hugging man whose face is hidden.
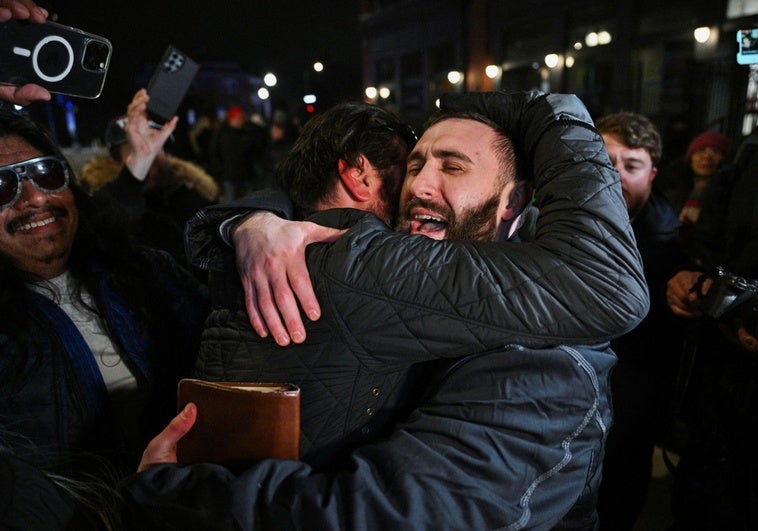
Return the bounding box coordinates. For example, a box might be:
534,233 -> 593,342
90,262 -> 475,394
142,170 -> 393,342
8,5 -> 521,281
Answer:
188,91 -> 648,464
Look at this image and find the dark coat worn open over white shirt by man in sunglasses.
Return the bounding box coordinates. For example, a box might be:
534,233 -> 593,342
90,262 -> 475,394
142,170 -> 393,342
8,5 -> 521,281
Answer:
0,249 -> 208,481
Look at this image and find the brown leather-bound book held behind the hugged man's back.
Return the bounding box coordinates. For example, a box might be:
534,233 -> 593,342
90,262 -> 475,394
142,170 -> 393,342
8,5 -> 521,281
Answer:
176,378 -> 300,464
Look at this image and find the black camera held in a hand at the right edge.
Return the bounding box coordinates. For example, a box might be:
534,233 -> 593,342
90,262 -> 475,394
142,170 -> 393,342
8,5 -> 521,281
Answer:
701,267 -> 758,337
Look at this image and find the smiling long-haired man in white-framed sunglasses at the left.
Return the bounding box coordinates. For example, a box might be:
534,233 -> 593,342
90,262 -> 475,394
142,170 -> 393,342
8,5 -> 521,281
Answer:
0,106 -> 207,484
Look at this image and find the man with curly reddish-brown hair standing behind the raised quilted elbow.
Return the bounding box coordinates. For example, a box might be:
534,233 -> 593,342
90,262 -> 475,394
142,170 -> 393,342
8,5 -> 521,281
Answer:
595,112 -> 687,531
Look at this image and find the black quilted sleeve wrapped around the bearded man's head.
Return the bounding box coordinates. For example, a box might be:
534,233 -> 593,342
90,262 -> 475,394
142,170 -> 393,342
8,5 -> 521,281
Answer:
308,93 -> 649,358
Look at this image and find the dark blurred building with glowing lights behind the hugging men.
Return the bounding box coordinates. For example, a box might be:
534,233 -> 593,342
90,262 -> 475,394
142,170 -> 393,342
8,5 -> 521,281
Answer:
360,0 -> 758,144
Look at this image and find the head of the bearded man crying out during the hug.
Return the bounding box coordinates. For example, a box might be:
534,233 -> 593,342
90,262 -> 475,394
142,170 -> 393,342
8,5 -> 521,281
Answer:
398,113 -> 531,241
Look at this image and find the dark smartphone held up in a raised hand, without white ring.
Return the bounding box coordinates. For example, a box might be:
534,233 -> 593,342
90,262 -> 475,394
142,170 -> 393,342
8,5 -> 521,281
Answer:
147,45 -> 200,124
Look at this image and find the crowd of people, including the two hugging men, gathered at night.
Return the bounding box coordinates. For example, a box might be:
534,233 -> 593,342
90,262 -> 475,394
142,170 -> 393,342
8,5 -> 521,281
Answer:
0,0 -> 758,530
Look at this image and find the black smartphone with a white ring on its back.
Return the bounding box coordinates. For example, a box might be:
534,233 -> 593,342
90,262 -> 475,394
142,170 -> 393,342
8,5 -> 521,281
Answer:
0,19 -> 112,99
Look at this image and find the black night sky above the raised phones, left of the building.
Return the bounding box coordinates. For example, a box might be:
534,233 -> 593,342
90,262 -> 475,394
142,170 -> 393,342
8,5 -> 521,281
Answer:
38,0 -> 361,143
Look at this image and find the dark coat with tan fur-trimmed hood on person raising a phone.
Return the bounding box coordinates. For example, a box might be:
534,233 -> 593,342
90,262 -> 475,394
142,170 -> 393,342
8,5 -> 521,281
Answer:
81,155 -> 219,266
